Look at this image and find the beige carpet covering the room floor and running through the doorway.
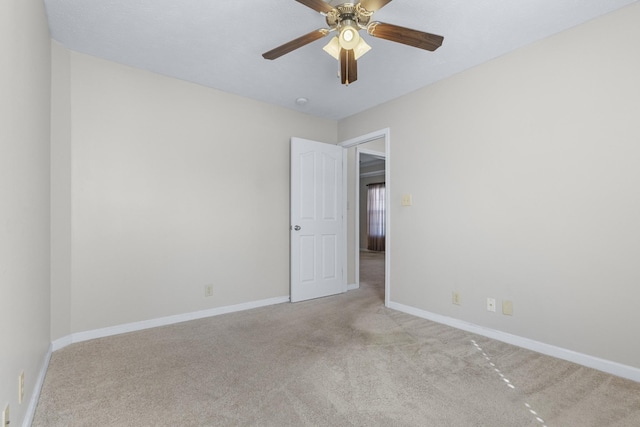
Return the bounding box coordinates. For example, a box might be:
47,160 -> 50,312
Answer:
33,253 -> 640,426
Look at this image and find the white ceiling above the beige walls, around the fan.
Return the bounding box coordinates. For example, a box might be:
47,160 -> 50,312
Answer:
45,0 -> 639,119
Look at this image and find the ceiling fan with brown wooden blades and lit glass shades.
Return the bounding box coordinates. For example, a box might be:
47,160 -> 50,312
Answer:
262,0 -> 444,85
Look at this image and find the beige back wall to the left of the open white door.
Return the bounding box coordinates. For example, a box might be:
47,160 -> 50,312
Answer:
52,49 -> 337,339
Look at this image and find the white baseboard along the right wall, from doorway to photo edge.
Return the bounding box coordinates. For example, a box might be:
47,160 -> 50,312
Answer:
388,302 -> 640,382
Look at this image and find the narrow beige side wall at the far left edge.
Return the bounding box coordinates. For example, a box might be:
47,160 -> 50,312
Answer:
0,0 -> 51,425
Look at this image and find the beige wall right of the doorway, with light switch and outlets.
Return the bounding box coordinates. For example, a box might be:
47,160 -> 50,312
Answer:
339,4 -> 640,367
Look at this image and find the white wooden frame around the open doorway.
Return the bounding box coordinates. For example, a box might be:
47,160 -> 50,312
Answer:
338,128 -> 392,307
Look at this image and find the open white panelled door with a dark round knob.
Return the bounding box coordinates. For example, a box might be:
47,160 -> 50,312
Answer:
291,138 -> 347,302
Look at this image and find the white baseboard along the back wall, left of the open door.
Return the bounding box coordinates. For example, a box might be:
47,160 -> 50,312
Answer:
51,295 -> 289,351
